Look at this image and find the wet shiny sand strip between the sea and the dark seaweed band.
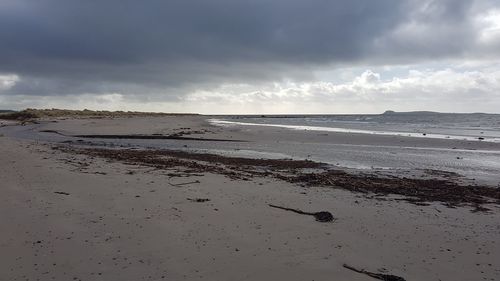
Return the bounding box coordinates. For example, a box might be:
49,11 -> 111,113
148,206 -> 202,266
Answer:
3,115 -> 500,187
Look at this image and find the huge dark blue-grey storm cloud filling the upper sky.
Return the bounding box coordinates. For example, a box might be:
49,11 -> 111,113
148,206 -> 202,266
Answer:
0,0 -> 497,94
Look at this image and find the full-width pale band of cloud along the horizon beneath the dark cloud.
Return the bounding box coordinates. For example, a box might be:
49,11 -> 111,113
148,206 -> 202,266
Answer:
0,65 -> 500,114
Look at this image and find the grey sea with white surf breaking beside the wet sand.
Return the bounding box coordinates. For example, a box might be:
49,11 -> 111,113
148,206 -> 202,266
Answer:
211,112 -> 500,142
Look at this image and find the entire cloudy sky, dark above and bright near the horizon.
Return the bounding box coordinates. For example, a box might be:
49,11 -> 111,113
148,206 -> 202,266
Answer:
0,0 -> 500,114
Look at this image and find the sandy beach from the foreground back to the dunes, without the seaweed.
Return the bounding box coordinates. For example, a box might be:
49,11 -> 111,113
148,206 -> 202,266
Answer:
0,115 -> 500,281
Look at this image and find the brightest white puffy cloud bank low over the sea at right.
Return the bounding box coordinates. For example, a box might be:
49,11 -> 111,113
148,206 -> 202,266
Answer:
181,69 -> 500,113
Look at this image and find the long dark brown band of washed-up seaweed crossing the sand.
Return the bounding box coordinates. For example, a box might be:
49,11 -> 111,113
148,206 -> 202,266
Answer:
54,146 -> 500,211
